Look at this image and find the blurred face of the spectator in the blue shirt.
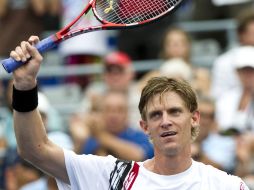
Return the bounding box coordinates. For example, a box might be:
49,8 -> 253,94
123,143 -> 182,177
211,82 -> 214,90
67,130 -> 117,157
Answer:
103,93 -> 128,134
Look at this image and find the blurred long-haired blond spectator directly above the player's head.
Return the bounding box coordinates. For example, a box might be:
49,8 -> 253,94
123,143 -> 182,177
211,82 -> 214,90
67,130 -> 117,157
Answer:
139,27 -> 210,94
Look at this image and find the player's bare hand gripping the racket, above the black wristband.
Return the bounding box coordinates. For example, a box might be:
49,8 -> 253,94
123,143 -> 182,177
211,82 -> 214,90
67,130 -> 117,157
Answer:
10,36 -> 43,90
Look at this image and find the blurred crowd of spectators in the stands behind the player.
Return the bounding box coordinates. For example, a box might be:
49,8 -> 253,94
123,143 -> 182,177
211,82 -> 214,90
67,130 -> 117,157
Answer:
0,0 -> 254,190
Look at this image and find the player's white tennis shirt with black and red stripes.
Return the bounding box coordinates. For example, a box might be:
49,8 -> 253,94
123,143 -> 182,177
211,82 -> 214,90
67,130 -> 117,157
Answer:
56,150 -> 249,190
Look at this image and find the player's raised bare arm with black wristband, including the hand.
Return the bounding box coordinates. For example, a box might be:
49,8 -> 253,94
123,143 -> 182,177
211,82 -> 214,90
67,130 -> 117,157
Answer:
10,36 -> 69,183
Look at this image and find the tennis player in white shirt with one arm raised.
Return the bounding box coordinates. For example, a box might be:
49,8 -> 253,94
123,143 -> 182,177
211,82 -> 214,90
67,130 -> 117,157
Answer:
11,36 -> 248,190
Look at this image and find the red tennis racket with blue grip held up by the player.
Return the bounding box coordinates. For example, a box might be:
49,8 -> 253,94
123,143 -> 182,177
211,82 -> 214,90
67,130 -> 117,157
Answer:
2,0 -> 183,73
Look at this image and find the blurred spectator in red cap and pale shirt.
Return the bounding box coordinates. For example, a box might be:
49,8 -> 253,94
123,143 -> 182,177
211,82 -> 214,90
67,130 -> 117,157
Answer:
81,51 -> 140,126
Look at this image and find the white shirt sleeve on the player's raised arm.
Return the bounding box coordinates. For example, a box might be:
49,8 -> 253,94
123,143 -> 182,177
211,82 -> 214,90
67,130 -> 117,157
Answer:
56,150 -> 116,190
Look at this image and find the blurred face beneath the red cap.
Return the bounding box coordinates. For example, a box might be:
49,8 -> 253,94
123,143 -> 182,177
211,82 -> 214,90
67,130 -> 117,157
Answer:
104,64 -> 133,91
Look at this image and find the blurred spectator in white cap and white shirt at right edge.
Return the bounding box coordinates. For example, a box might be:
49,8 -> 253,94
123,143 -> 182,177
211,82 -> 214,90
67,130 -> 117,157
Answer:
212,46 -> 254,189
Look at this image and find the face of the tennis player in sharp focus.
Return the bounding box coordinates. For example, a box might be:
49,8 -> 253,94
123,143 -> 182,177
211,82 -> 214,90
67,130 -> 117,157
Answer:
140,92 -> 199,156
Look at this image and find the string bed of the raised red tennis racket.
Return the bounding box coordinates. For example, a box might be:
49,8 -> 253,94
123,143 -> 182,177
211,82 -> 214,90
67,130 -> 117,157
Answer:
95,0 -> 182,24
